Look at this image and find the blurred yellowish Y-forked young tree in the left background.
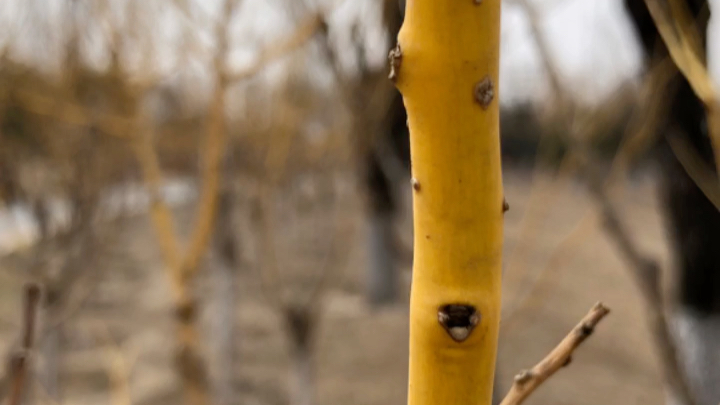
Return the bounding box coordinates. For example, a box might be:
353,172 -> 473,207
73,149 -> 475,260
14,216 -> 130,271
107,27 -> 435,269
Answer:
129,0 -> 236,405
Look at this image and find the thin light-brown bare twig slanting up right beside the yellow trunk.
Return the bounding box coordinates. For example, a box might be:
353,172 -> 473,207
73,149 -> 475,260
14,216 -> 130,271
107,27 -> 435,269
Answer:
500,303 -> 610,405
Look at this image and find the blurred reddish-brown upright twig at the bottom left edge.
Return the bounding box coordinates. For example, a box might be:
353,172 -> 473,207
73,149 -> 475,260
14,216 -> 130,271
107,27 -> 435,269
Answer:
7,284 -> 40,405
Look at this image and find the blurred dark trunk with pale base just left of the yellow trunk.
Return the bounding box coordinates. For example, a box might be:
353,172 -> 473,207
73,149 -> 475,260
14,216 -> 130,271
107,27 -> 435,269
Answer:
358,0 -> 409,306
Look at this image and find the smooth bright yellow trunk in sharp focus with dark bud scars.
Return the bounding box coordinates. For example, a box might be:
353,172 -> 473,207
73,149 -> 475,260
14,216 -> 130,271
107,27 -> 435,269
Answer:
390,0 -> 506,405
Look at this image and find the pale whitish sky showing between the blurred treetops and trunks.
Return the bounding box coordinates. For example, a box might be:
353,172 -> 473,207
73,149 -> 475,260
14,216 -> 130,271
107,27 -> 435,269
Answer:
0,0 -> 720,103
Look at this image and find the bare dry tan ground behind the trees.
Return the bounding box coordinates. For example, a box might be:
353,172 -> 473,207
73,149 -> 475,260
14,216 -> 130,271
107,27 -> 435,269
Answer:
0,166 -> 667,405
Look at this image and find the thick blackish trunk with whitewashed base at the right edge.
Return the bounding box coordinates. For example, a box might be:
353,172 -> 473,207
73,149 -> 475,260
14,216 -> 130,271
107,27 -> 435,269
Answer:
625,0 -> 720,405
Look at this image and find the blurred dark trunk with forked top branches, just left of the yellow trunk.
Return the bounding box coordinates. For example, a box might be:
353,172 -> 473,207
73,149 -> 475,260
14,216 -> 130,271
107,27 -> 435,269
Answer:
312,0 -> 409,306
